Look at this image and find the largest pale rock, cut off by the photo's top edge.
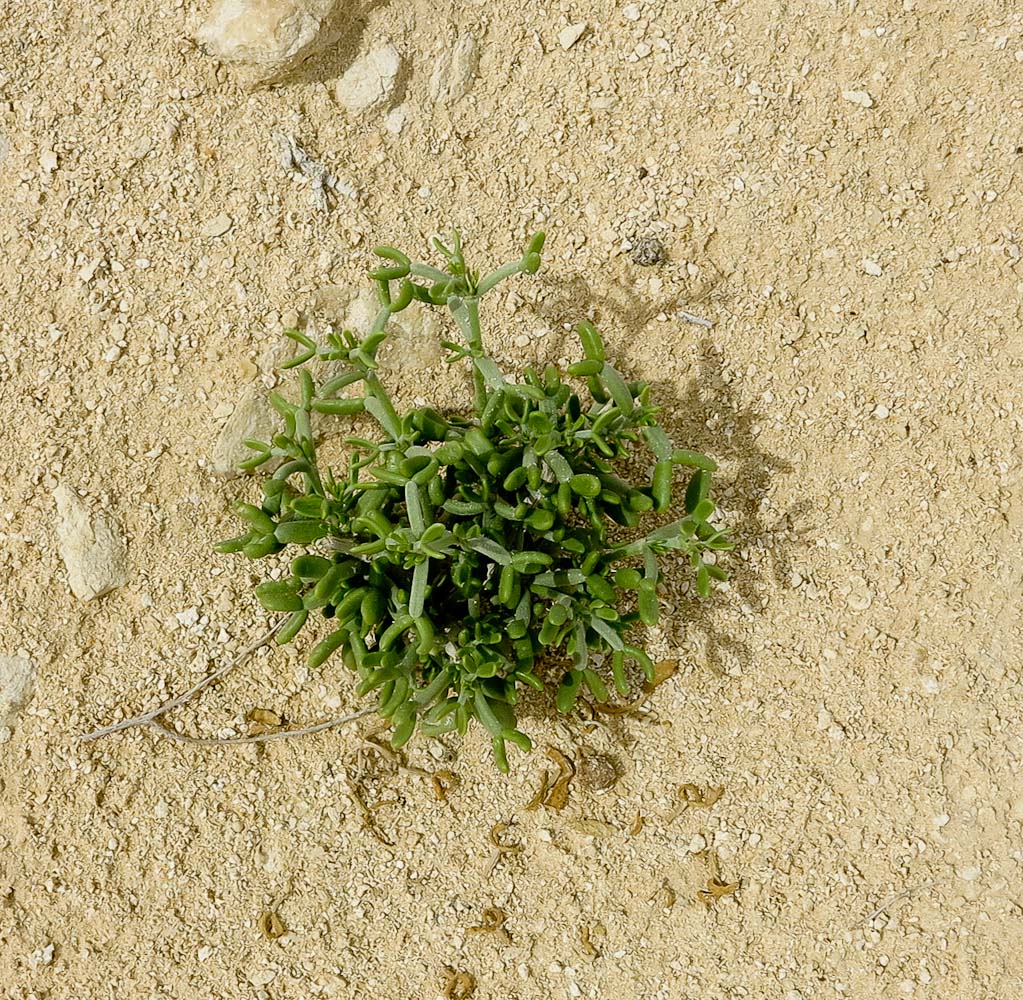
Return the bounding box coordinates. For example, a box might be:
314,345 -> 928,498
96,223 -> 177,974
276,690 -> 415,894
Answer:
195,0 -> 345,82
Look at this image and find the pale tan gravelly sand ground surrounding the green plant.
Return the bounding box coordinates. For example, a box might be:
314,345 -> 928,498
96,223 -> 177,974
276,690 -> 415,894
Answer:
0,0 -> 1023,1000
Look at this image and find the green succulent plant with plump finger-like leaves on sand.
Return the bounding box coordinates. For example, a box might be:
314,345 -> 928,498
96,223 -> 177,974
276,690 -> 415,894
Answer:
217,233 -> 731,771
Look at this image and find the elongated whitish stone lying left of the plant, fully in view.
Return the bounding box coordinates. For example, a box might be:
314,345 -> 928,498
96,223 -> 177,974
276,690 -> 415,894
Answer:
53,485 -> 127,600
